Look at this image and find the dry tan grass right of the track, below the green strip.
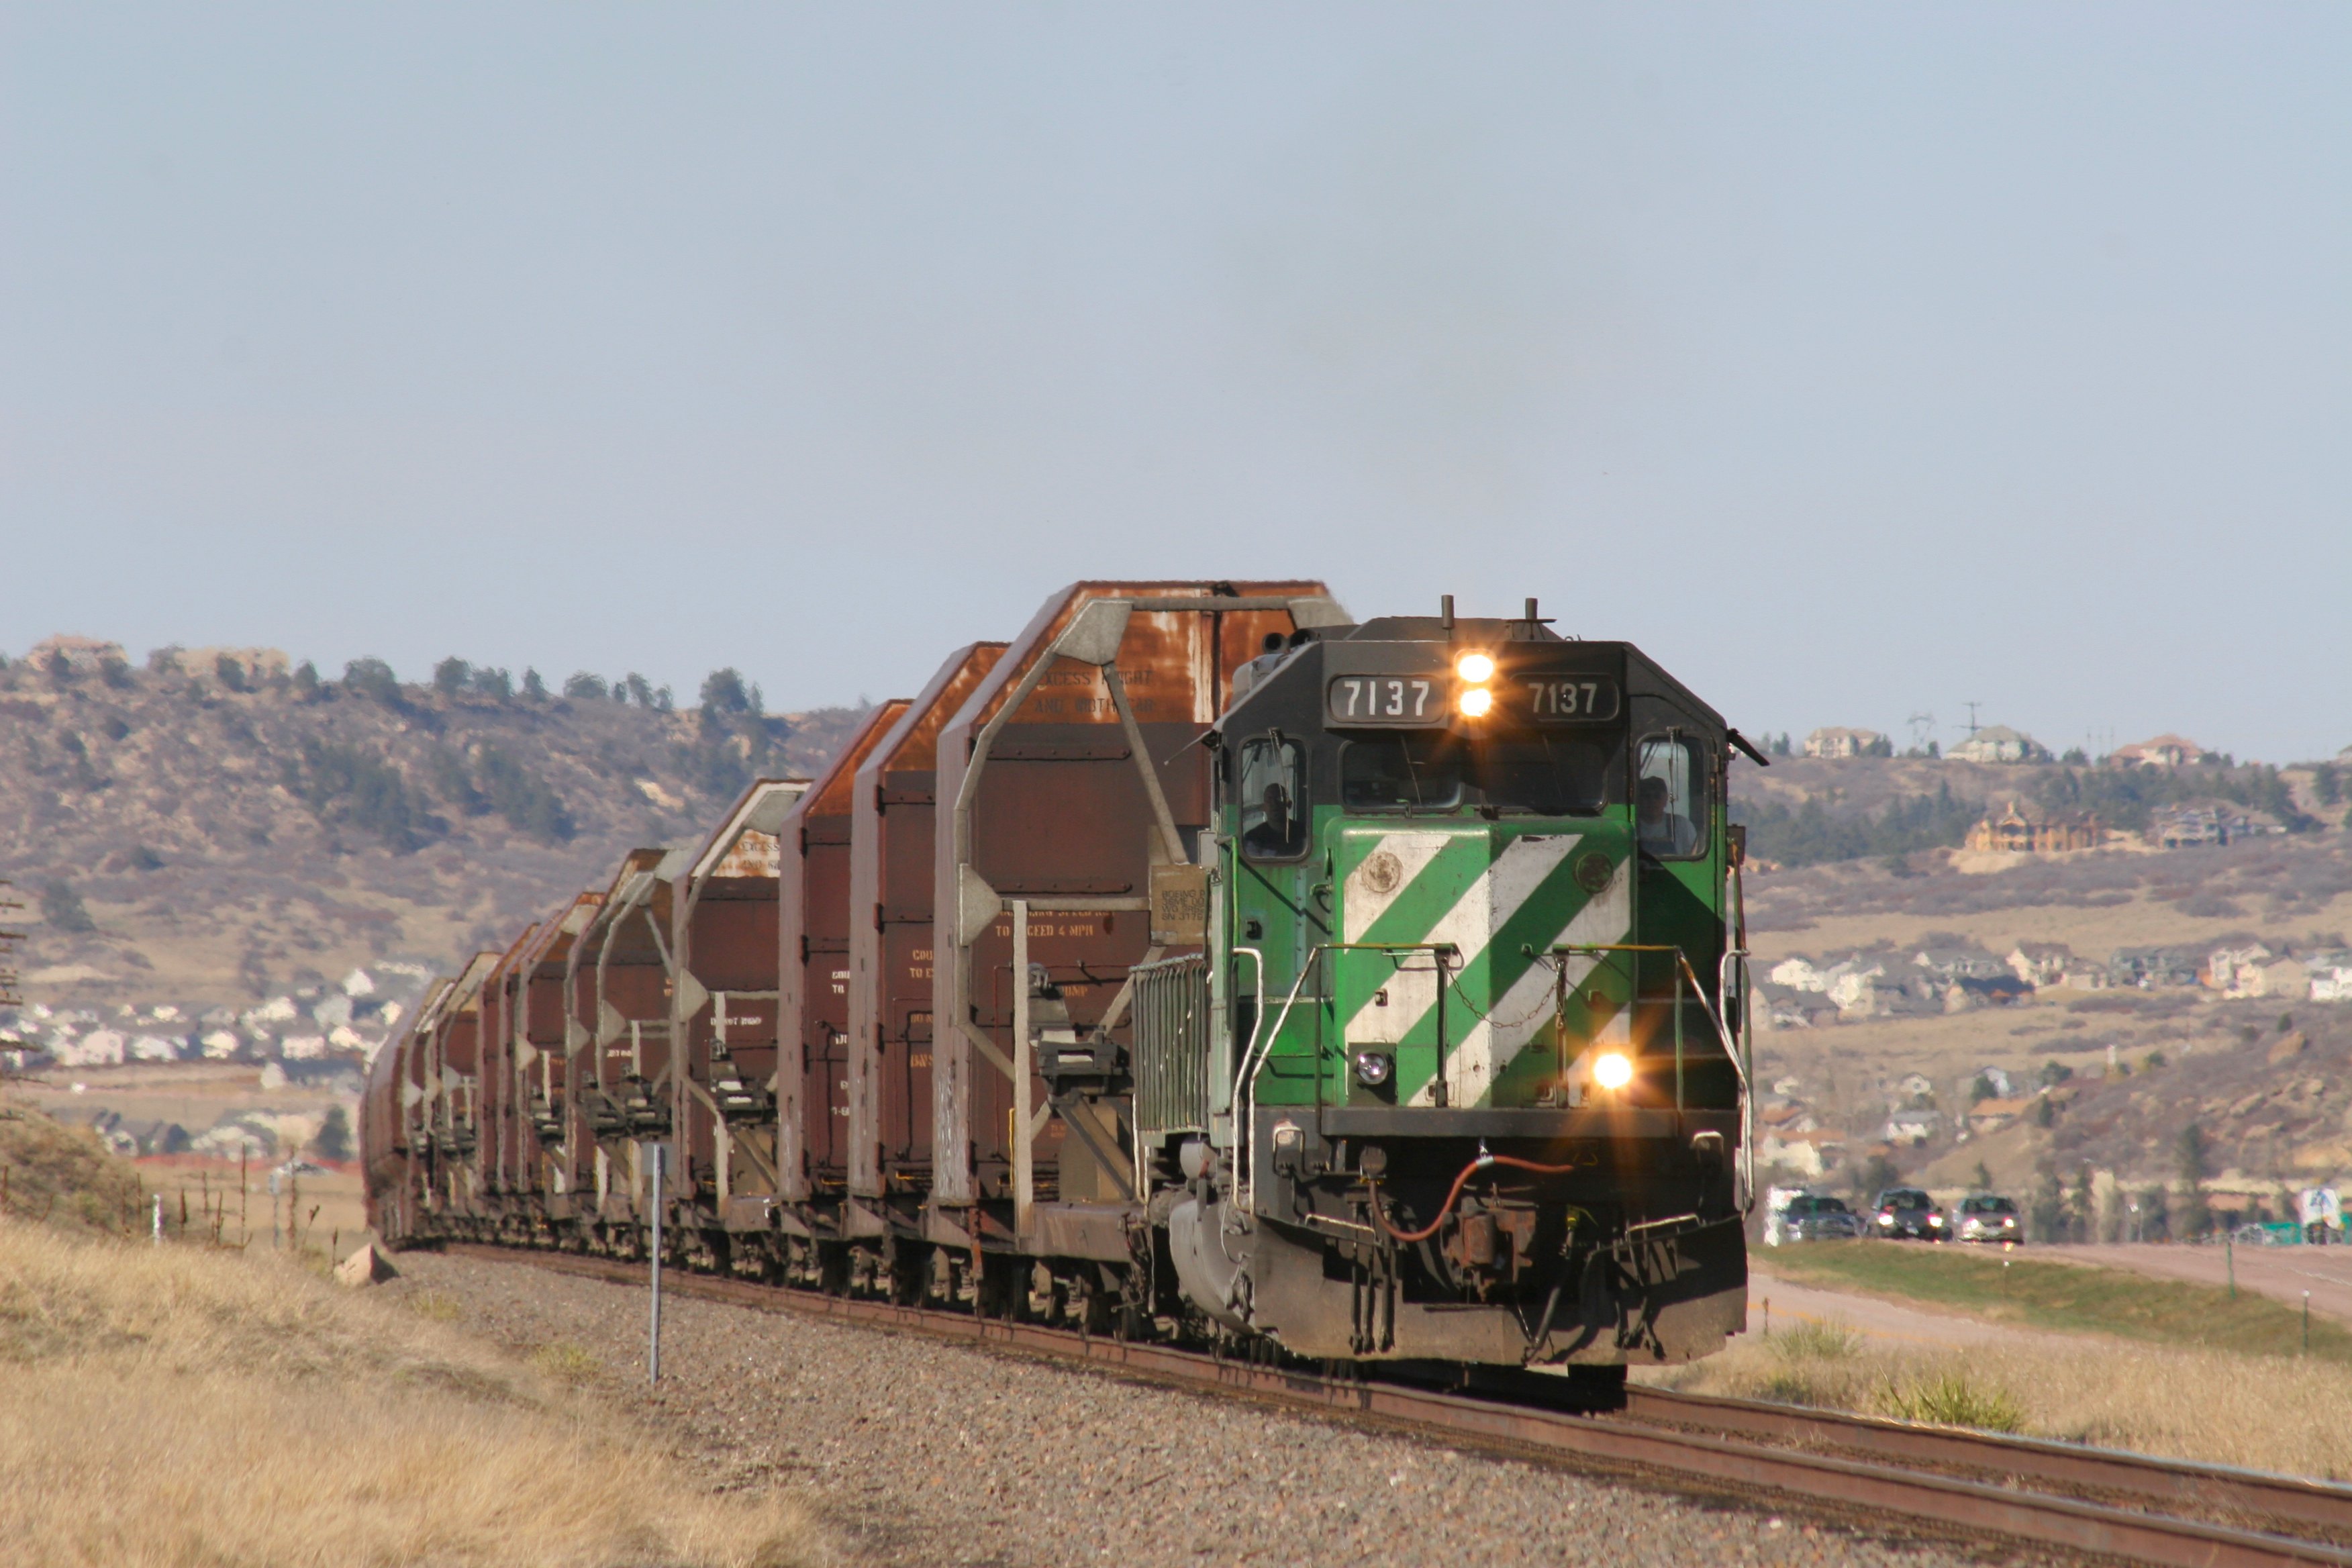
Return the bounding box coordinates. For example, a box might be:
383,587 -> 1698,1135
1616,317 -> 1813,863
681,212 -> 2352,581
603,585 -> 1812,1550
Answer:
1642,1324 -> 2352,1481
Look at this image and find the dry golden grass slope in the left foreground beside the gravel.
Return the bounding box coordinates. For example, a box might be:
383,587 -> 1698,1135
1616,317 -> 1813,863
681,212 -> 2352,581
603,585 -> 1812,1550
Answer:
0,1220 -> 818,1568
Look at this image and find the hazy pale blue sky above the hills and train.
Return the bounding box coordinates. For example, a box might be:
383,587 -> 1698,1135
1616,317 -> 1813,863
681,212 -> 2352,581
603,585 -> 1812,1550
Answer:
0,0 -> 2352,759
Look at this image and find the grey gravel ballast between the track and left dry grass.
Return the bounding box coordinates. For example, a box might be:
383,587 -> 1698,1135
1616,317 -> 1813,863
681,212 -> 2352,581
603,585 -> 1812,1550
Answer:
383,1253 -> 2011,1568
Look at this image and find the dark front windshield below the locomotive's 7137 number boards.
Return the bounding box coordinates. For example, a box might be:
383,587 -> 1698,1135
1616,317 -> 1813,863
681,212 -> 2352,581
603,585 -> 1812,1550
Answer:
1338,731 -> 1618,816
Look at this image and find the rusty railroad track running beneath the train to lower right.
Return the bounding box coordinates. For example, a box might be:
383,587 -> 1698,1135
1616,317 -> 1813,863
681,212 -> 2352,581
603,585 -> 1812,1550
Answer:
447,1244 -> 2352,1568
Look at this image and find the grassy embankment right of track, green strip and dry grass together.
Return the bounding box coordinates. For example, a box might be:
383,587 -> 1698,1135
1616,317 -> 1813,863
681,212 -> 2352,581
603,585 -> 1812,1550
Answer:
1644,1244 -> 2352,1481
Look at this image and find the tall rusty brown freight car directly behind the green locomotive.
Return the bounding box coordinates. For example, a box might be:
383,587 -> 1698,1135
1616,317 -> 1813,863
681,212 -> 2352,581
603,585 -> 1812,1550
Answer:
927,581 -> 1345,1293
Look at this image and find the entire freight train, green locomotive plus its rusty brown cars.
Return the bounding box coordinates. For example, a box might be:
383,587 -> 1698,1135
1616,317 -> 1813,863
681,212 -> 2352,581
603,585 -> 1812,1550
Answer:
362,581 -> 1761,1387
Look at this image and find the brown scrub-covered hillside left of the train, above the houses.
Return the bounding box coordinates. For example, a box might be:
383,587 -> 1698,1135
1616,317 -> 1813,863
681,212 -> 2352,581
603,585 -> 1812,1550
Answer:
0,644 -> 859,1016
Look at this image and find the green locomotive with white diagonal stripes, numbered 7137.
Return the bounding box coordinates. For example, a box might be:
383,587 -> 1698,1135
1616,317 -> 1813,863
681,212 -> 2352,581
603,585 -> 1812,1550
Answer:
1134,599 -> 1761,1366
